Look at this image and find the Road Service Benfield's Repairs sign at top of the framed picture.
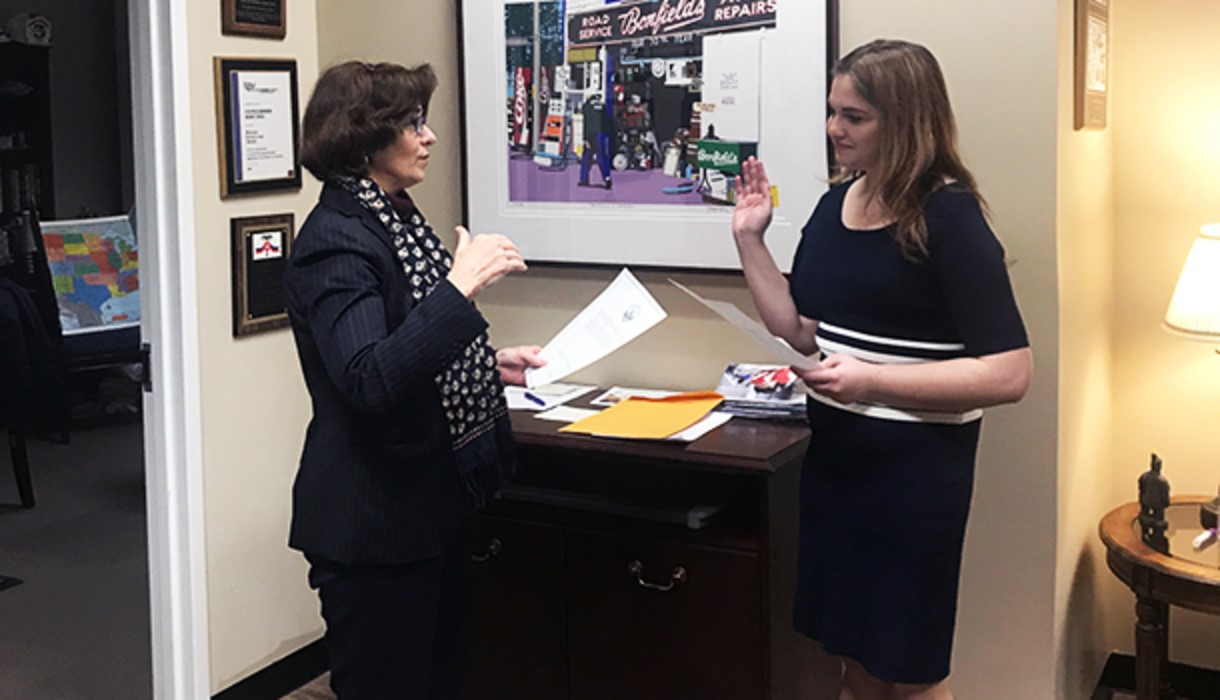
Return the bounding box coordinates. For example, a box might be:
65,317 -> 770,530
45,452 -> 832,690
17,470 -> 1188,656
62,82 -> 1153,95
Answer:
567,0 -> 775,46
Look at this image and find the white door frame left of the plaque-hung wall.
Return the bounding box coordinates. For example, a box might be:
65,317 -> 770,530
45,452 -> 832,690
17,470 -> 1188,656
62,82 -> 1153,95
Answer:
129,0 -> 211,700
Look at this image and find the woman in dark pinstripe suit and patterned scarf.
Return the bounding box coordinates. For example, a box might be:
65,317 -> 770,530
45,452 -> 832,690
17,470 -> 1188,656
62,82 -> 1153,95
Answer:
284,61 -> 543,700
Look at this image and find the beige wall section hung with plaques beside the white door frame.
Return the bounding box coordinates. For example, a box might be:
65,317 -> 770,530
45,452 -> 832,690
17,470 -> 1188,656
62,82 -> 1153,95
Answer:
181,0 -> 318,693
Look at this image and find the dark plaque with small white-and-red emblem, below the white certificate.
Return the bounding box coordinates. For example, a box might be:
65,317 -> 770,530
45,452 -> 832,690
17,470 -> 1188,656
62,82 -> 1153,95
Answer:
229,213 -> 293,337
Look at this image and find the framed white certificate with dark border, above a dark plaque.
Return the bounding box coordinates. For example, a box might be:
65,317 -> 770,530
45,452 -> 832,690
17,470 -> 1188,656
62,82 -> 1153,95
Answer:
215,57 -> 301,198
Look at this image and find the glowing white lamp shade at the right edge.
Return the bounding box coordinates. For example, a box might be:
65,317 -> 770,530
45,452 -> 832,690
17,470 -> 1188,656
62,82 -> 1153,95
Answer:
1165,223 -> 1220,340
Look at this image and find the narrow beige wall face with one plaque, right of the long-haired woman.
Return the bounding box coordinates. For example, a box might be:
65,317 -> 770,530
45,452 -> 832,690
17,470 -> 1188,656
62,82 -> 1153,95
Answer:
1055,0 -> 1115,698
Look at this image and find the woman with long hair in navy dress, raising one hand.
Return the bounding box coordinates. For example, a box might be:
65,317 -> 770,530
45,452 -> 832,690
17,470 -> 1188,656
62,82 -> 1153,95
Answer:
733,40 -> 1032,700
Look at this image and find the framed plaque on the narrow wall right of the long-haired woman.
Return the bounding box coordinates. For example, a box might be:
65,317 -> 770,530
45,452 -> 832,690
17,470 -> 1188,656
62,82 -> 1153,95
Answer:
1074,0 -> 1110,129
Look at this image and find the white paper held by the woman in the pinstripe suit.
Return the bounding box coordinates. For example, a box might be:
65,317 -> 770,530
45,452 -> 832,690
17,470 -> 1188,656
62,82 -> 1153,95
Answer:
526,267 -> 666,389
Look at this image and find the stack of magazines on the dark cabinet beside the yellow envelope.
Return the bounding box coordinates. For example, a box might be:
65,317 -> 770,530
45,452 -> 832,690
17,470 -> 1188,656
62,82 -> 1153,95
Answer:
716,362 -> 805,421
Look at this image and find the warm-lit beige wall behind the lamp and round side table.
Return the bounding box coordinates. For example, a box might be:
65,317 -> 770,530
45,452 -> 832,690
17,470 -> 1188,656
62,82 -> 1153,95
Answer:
1099,0 -> 1220,668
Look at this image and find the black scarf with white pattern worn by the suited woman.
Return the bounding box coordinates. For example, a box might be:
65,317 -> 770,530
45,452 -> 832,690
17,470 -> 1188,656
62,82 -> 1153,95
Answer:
338,178 -> 516,510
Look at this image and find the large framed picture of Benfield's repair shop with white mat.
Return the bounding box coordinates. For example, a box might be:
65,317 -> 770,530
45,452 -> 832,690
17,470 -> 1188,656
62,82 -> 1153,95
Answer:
461,0 -> 837,268
